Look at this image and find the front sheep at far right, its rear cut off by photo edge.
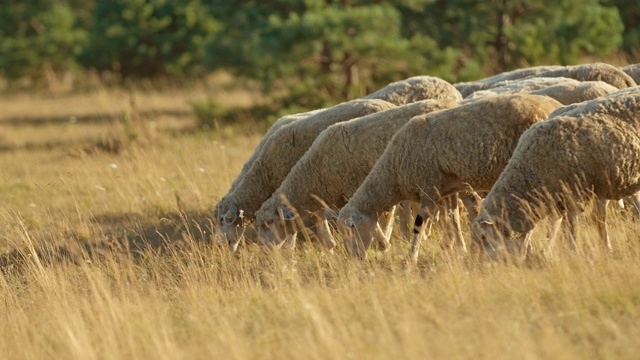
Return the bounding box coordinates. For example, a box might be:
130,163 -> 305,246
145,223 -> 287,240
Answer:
472,87 -> 640,255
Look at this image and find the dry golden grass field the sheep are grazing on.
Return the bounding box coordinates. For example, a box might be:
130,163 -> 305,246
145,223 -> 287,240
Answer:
0,83 -> 640,359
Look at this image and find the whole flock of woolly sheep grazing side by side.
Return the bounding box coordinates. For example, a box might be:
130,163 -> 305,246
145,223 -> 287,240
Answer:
214,63 -> 640,261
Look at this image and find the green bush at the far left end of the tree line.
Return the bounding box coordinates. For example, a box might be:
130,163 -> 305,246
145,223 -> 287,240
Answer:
0,0 -> 87,79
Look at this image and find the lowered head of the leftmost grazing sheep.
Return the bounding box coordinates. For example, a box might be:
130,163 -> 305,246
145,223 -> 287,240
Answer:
213,199 -> 244,251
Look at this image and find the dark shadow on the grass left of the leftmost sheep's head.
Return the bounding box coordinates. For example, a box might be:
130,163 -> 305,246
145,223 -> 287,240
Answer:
0,211 -> 213,273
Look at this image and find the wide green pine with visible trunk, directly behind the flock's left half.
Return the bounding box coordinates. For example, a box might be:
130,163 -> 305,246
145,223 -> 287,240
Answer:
208,1 -> 422,108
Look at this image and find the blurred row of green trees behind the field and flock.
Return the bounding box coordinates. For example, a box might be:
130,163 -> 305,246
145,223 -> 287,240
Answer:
0,0 -> 640,109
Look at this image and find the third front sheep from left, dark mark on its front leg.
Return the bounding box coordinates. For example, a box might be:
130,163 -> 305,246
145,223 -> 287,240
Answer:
338,94 -> 561,261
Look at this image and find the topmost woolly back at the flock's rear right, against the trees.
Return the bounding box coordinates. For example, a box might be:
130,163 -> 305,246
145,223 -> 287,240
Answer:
535,62 -> 637,89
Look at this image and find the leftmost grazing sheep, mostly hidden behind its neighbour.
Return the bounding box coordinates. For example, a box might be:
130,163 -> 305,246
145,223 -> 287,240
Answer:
214,99 -> 395,250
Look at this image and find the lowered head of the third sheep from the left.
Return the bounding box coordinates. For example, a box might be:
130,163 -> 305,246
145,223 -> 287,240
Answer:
338,204 -> 385,259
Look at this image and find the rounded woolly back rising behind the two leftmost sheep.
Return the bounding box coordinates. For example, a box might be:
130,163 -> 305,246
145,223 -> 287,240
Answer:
363,76 -> 462,105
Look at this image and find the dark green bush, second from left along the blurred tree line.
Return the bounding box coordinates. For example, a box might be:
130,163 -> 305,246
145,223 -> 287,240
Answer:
82,0 -> 216,77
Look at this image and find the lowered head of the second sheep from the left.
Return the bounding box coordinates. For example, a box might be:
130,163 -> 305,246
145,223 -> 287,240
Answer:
256,197 -> 297,247
